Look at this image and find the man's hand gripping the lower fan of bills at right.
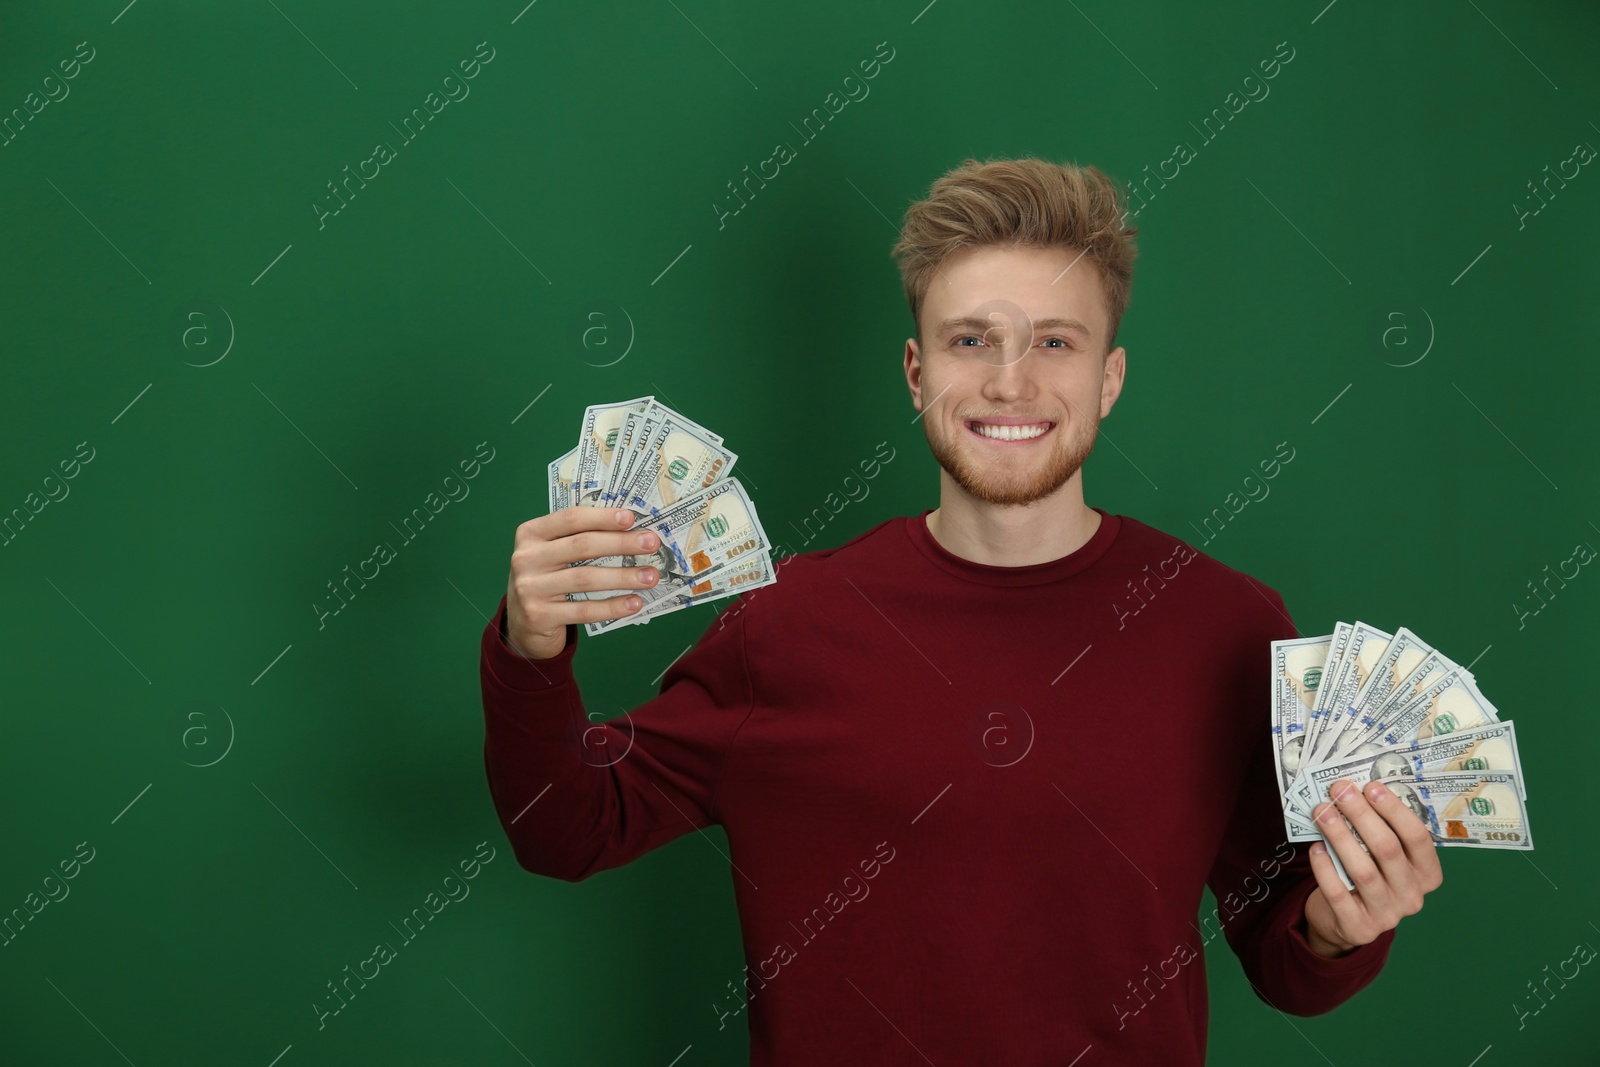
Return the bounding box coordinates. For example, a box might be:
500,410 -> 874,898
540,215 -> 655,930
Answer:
1306,779 -> 1445,958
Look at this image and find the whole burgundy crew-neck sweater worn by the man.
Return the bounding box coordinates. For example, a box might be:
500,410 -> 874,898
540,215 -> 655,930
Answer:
480,509 -> 1394,1067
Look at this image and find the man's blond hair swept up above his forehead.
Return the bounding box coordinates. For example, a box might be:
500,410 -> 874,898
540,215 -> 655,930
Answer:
890,158 -> 1138,352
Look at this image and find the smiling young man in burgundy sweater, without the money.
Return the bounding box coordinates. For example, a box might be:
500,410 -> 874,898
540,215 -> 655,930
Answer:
482,160 -> 1442,1067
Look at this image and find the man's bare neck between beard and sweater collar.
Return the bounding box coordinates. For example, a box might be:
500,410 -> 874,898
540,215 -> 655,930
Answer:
926,469 -> 1101,566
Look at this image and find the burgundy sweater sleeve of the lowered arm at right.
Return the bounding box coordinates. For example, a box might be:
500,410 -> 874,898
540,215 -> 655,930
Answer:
1208,587 -> 1395,1016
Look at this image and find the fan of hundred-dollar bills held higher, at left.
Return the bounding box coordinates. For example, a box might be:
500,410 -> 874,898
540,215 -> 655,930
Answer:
550,397 -> 778,635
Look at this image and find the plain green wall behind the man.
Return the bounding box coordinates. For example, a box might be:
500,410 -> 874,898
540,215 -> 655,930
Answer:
0,0 -> 1600,1067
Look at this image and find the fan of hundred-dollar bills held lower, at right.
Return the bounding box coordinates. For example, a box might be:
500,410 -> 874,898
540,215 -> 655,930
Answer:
1272,622 -> 1533,885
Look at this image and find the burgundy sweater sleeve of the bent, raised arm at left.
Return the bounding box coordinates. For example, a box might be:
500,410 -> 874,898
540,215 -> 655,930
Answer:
478,597 -> 755,881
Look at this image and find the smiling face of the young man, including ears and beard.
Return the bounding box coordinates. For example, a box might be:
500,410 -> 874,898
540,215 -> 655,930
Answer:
906,248 -> 1126,506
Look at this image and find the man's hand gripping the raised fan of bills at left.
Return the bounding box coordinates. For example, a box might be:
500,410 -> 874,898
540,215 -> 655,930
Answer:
506,504 -> 661,659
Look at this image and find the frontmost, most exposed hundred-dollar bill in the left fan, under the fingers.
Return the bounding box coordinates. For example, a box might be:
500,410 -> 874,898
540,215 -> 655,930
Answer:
566,478 -> 771,611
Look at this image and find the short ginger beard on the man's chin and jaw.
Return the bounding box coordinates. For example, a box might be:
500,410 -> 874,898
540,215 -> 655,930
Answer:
922,384 -> 1099,506
